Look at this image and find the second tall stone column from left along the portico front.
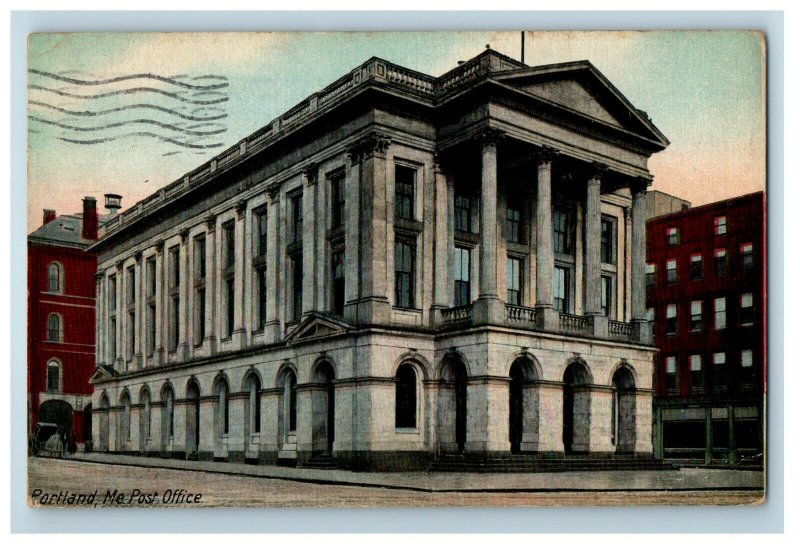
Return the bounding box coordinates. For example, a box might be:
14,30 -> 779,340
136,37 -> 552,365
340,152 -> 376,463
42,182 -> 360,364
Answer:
536,147 -> 558,330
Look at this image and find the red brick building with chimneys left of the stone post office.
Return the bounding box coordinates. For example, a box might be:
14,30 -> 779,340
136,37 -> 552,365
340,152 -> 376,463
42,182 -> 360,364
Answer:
28,195 -> 118,447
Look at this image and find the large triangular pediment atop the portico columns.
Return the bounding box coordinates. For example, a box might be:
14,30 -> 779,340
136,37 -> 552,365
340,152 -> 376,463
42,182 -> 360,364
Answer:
494,61 -> 669,147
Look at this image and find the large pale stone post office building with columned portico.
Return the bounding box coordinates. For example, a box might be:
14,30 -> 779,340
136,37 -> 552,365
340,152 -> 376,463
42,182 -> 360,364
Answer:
92,49 -> 669,469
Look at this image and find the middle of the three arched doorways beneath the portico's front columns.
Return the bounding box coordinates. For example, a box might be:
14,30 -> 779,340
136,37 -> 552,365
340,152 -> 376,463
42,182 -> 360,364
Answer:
563,361 -> 591,454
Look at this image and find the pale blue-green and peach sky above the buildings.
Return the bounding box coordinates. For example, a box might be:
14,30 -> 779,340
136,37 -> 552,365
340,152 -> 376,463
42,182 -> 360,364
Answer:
23,31 -> 766,232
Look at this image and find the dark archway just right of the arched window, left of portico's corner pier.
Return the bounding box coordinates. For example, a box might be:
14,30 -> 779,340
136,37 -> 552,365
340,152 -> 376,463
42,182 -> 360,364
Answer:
437,355 -> 467,453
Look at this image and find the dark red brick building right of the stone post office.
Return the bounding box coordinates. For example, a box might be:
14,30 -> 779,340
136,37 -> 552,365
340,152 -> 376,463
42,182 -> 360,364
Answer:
647,192 -> 766,464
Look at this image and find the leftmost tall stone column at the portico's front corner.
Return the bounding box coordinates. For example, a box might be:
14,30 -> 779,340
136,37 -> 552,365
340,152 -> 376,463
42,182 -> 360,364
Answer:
474,129 -> 505,323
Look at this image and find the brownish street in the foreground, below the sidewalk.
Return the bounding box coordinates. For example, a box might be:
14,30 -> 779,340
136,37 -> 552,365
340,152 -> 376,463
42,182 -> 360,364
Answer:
28,458 -> 764,508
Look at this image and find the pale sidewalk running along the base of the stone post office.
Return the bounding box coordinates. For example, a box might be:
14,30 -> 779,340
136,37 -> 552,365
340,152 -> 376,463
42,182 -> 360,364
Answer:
70,453 -> 764,493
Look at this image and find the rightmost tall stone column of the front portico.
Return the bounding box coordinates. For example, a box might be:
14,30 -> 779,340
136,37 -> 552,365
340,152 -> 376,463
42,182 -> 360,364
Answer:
630,179 -> 653,344
